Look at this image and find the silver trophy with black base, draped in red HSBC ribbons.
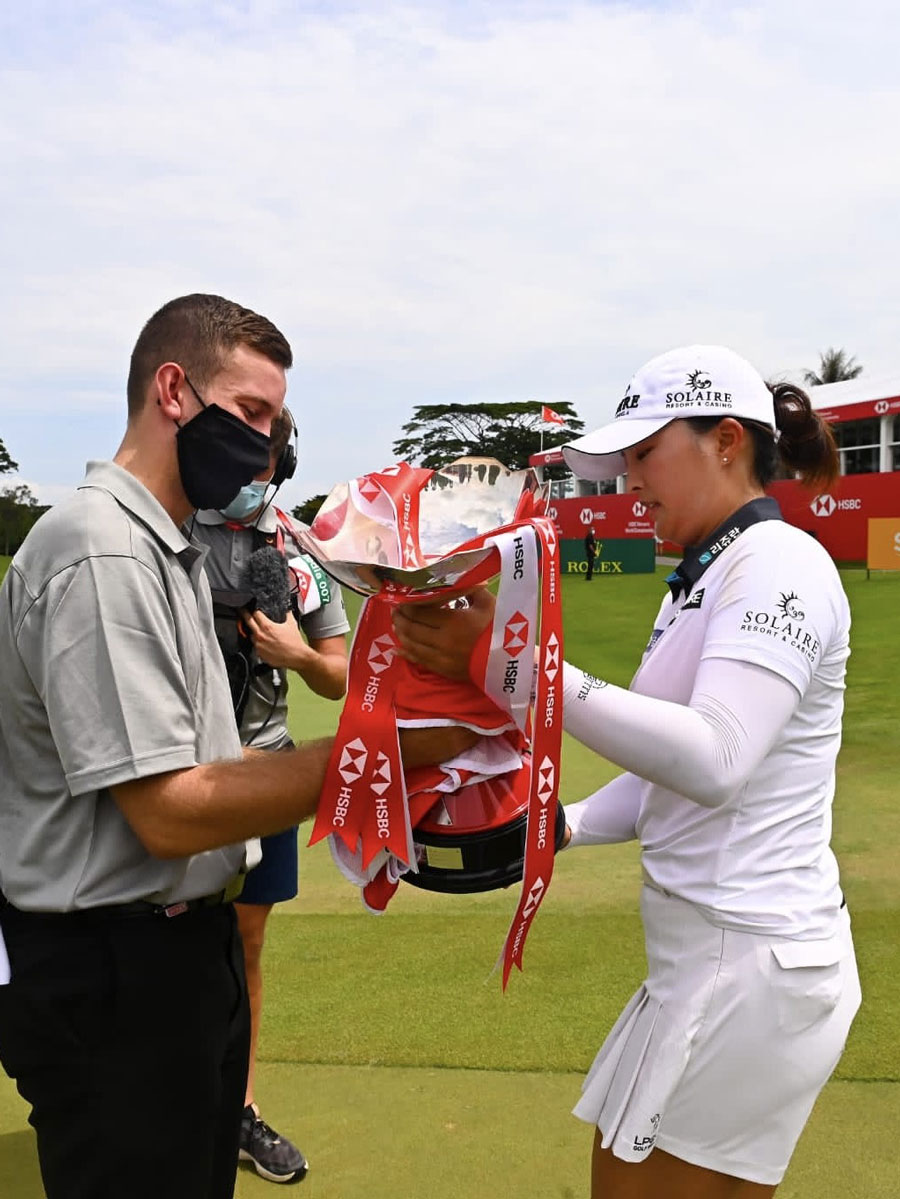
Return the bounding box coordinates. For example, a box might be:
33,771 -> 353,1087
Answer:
298,458 -> 564,987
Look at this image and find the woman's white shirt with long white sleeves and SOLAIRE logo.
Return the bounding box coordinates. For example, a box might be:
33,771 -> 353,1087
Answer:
563,520 -> 850,939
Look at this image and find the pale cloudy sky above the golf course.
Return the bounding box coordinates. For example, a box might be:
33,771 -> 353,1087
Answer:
0,0 -> 900,504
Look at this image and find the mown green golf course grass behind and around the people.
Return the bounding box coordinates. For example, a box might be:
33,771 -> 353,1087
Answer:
0,567 -> 900,1199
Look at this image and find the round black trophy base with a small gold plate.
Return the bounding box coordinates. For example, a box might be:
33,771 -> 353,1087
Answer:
403,803 -> 566,894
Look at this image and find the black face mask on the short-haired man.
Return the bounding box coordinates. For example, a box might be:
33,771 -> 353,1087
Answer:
175,375 -> 271,508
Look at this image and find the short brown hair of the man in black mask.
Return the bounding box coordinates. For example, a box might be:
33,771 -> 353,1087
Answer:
128,294 -> 294,416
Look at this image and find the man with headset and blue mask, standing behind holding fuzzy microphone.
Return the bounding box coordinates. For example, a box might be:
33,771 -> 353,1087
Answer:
186,404 -> 350,1183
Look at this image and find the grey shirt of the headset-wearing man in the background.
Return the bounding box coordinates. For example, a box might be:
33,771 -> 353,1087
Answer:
187,505 -> 350,749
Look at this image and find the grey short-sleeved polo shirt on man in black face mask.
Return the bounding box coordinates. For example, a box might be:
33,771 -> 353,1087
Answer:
0,463 -> 250,911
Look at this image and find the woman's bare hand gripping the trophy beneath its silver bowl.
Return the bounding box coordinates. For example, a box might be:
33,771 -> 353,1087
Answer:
393,588 -> 496,679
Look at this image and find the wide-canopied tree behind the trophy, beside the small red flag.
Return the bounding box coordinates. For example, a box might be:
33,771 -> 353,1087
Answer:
393,400 -> 585,470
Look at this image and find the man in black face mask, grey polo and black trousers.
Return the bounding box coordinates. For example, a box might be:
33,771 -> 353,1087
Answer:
0,295 -> 330,1199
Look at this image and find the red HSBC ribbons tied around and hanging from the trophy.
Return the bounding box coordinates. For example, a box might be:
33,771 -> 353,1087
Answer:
309,472 -> 562,989
